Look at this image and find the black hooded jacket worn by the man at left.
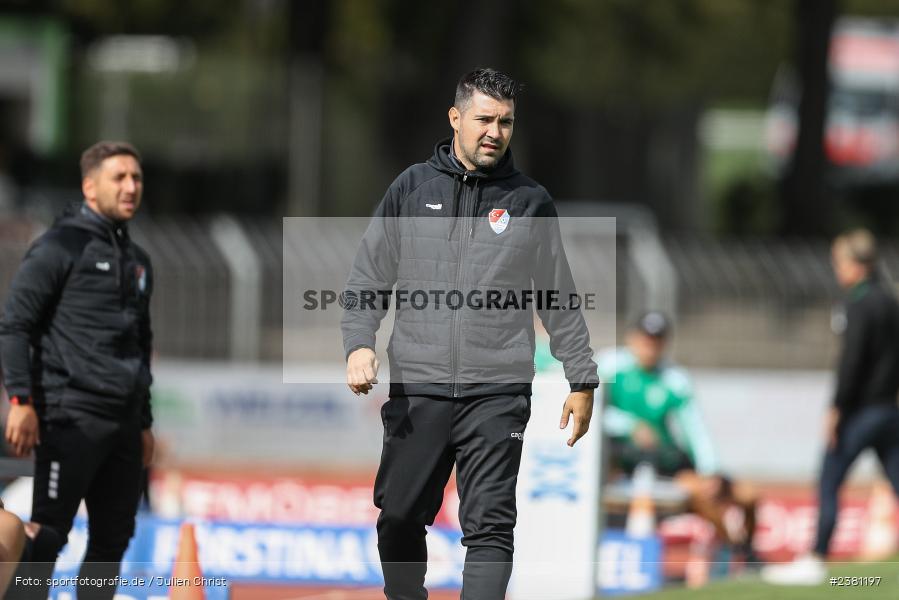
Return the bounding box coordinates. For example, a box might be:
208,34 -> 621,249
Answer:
0,205 -> 153,428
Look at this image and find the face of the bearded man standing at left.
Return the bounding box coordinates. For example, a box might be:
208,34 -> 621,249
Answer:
81,154 -> 144,221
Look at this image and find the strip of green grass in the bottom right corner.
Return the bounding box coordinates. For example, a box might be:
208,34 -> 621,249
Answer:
630,556 -> 899,600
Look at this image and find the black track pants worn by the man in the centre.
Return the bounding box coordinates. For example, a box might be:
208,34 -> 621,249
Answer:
375,395 -> 531,600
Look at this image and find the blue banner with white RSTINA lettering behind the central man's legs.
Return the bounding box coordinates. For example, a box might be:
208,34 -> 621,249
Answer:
44,514 -> 465,600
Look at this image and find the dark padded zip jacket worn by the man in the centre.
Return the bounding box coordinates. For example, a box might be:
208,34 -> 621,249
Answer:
342,140 -> 598,397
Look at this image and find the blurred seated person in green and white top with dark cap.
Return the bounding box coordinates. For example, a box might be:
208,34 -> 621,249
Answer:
597,312 -> 757,562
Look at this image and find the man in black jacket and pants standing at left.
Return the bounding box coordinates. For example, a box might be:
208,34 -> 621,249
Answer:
0,142 -> 154,599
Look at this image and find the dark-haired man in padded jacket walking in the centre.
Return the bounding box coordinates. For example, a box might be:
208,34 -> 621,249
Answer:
342,69 -> 598,600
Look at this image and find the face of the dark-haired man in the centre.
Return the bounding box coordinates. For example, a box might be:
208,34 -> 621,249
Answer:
449,91 -> 515,171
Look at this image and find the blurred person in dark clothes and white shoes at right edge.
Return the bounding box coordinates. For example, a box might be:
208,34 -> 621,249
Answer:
763,229 -> 899,585
